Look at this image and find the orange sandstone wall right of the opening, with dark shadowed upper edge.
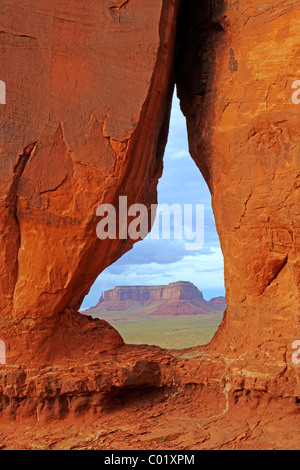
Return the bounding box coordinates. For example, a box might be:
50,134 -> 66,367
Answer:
177,0 -> 300,376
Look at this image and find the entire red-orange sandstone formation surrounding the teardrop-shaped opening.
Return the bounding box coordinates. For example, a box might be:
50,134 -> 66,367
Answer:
0,0 -> 300,449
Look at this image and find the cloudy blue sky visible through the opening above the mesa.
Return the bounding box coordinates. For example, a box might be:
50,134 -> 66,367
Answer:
82,97 -> 225,308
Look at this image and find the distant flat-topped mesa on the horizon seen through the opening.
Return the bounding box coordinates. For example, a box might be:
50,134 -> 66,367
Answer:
85,281 -> 226,318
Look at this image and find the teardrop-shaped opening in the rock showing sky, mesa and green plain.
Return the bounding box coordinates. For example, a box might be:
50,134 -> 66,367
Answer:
82,93 -> 226,348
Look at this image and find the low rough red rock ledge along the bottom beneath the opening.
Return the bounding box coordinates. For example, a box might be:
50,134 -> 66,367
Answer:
0,345 -> 299,452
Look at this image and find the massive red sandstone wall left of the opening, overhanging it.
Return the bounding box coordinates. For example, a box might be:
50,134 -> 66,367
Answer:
0,0 -> 178,364
